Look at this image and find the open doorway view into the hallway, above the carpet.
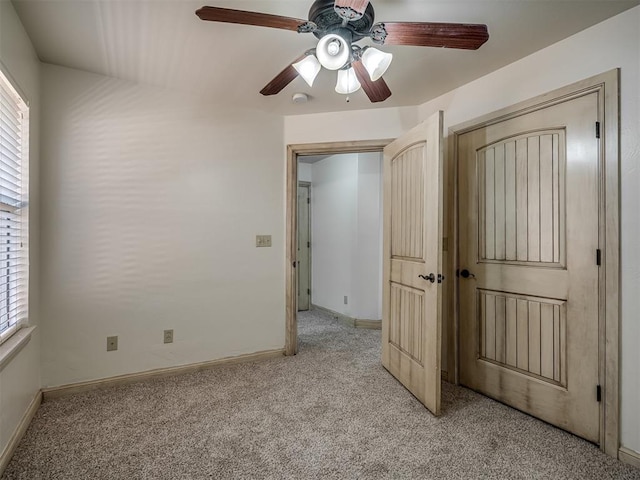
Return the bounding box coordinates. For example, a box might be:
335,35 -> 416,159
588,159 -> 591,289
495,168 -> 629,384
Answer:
296,152 -> 382,329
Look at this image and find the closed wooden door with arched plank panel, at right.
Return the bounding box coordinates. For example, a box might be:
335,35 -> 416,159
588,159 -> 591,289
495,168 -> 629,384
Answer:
457,93 -> 600,442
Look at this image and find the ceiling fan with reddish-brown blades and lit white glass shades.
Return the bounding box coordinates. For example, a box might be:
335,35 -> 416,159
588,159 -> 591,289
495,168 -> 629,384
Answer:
196,0 -> 489,102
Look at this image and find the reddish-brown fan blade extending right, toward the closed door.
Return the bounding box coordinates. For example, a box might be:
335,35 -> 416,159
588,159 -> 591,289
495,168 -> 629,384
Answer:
378,22 -> 489,50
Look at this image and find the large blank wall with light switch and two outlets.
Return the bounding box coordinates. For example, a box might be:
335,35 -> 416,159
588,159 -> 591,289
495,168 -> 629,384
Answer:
42,65 -> 285,387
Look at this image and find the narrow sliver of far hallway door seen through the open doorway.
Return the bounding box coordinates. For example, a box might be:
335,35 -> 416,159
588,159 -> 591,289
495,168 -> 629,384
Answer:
297,182 -> 311,311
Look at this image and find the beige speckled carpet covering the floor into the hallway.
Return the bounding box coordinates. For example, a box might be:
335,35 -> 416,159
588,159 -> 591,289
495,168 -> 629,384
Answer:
2,312 -> 640,480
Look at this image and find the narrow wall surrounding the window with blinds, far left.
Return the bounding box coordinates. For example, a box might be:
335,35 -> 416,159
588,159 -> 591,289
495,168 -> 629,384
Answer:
0,1 -> 40,462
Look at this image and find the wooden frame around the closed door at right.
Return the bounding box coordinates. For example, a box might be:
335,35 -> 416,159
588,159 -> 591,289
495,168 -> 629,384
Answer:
445,69 -> 620,458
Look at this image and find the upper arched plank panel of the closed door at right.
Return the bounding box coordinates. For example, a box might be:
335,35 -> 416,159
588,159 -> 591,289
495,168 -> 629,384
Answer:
477,130 -> 565,267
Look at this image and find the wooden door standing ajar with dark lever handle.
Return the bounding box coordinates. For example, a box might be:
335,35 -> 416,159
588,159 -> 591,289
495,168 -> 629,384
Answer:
382,112 -> 444,415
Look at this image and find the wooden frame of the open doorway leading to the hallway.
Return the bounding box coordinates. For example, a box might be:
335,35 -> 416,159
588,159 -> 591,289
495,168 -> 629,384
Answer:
284,139 -> 393,355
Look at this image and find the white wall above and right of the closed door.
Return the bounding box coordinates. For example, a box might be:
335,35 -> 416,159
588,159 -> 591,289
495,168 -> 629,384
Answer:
419,7 -> 640,452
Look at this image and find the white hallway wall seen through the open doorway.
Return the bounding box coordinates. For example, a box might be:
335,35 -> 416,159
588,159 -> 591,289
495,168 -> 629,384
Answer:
311,153 -> 381,320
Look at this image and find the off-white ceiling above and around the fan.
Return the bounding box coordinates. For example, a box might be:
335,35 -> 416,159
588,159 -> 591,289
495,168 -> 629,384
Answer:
13,0 -> 640,114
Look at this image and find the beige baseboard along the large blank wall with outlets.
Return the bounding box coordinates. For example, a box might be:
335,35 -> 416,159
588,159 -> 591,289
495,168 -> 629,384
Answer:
42,349 -> 284,401
